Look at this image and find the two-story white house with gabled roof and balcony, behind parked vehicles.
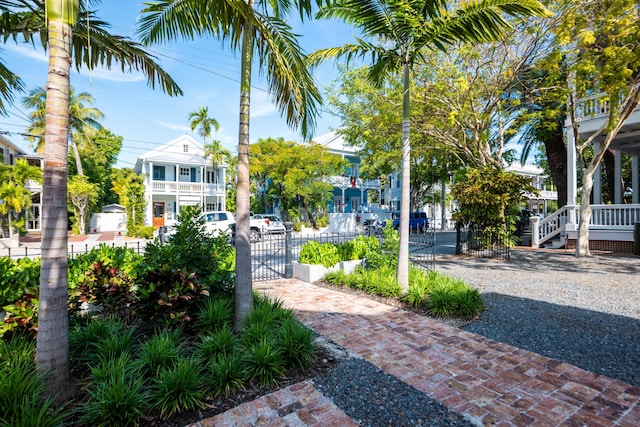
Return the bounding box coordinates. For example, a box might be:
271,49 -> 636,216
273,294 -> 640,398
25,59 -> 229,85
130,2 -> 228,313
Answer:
134,135 -> 228,228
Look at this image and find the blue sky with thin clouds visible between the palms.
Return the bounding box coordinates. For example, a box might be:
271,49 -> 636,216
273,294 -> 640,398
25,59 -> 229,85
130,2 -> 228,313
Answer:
0,0 -> 354,167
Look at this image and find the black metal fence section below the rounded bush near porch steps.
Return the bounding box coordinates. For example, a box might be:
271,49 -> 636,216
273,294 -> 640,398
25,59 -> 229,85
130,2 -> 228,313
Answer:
456,224 -> 513,260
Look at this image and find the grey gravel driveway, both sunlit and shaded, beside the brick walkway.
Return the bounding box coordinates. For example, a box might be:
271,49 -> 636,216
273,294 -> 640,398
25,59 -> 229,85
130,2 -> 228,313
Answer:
436,249 -> 640,386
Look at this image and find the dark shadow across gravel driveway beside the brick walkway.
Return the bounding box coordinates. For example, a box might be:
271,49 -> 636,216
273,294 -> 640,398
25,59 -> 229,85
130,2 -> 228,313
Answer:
462,292 -> 640,386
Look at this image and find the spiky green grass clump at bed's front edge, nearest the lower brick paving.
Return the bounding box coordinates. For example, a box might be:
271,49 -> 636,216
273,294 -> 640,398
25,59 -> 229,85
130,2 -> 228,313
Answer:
150,357 -> 204,418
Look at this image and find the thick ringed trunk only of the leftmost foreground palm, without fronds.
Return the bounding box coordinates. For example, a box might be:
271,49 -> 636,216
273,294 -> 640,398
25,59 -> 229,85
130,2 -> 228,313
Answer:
36,15 -> 72,400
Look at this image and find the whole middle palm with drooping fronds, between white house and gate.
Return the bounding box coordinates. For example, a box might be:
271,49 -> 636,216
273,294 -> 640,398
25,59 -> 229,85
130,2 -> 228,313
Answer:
138,0 -> 321,329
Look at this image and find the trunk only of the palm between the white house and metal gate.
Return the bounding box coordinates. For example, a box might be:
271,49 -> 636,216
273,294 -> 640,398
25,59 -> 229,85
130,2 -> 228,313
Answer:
234,20 -> 254,331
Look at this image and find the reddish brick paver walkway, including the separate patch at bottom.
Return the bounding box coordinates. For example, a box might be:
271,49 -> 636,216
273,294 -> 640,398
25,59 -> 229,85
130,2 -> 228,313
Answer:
192,279 -> 640,427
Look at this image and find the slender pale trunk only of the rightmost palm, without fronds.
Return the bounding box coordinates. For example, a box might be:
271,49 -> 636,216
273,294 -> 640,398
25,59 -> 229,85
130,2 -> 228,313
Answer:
396,63 -> 411,293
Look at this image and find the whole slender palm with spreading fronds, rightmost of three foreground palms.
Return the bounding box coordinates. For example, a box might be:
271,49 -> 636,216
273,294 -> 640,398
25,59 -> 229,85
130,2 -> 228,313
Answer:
312,0 -> 547,292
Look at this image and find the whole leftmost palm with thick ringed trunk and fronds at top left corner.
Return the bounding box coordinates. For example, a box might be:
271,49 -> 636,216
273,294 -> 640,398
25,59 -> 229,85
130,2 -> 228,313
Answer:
0,0 -> 182,400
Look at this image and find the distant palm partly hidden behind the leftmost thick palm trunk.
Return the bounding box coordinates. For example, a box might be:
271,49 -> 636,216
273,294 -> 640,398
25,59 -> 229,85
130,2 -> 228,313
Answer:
22,87 -> 104,175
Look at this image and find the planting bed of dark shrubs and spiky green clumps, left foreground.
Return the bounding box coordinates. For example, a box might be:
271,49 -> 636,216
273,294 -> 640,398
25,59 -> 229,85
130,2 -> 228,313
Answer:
0,206 -> 317,426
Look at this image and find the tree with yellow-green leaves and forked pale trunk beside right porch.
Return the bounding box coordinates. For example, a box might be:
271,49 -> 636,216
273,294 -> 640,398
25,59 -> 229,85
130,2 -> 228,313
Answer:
556,0 -> 640,257
